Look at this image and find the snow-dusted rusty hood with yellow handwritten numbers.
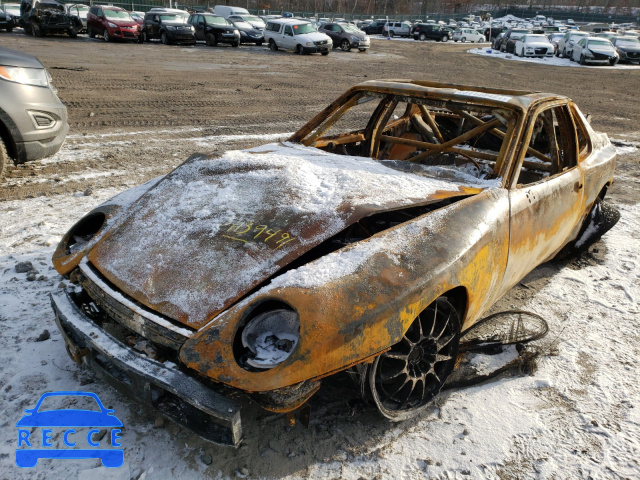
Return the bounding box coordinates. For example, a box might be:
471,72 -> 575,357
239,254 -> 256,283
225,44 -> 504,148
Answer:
89,143 -> 496,328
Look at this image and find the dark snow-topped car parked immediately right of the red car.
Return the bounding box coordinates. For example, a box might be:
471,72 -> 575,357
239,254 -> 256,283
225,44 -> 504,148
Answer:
140,9 -> 196,45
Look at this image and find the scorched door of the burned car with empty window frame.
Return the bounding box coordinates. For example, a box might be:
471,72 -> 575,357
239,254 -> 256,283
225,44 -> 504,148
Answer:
504,102 -> 586,288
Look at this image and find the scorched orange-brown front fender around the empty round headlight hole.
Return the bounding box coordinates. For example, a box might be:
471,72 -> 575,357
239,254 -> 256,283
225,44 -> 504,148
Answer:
180,188 -> 509,392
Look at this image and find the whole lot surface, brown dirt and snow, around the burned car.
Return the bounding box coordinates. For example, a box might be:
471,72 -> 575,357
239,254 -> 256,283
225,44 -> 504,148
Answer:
0,31 -> 640,479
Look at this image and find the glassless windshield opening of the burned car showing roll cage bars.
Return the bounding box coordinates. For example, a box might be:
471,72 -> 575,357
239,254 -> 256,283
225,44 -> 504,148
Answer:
292,92 -> 518,183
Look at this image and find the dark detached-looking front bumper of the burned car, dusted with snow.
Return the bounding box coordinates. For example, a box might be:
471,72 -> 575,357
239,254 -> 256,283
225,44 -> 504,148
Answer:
51,291 -> 242,447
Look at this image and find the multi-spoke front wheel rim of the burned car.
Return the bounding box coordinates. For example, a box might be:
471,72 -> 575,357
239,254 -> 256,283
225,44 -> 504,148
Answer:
369,297 -> 460,421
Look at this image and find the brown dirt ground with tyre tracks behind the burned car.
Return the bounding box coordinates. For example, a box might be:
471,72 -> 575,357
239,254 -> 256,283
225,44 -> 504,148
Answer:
0,32 -> 640,200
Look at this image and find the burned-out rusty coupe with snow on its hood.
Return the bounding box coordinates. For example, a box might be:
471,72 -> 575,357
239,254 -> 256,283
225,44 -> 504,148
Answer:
51,80 -> 616,444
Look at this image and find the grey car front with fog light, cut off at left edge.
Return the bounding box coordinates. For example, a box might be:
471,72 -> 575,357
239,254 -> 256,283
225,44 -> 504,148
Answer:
0,47 -> 69,178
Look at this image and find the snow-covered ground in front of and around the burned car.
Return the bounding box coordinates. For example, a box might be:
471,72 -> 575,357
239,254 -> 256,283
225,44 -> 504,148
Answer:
0,137 -> 640,480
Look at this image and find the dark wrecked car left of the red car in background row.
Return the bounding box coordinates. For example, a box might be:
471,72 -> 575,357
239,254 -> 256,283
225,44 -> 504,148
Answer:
18,0 -> 84,38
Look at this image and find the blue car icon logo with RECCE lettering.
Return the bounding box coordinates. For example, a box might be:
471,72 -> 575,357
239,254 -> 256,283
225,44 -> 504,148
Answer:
16,392 -> 124,468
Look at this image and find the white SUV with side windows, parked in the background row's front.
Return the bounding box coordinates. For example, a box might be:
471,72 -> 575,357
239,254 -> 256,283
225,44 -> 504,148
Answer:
264,18 -> 333,55
